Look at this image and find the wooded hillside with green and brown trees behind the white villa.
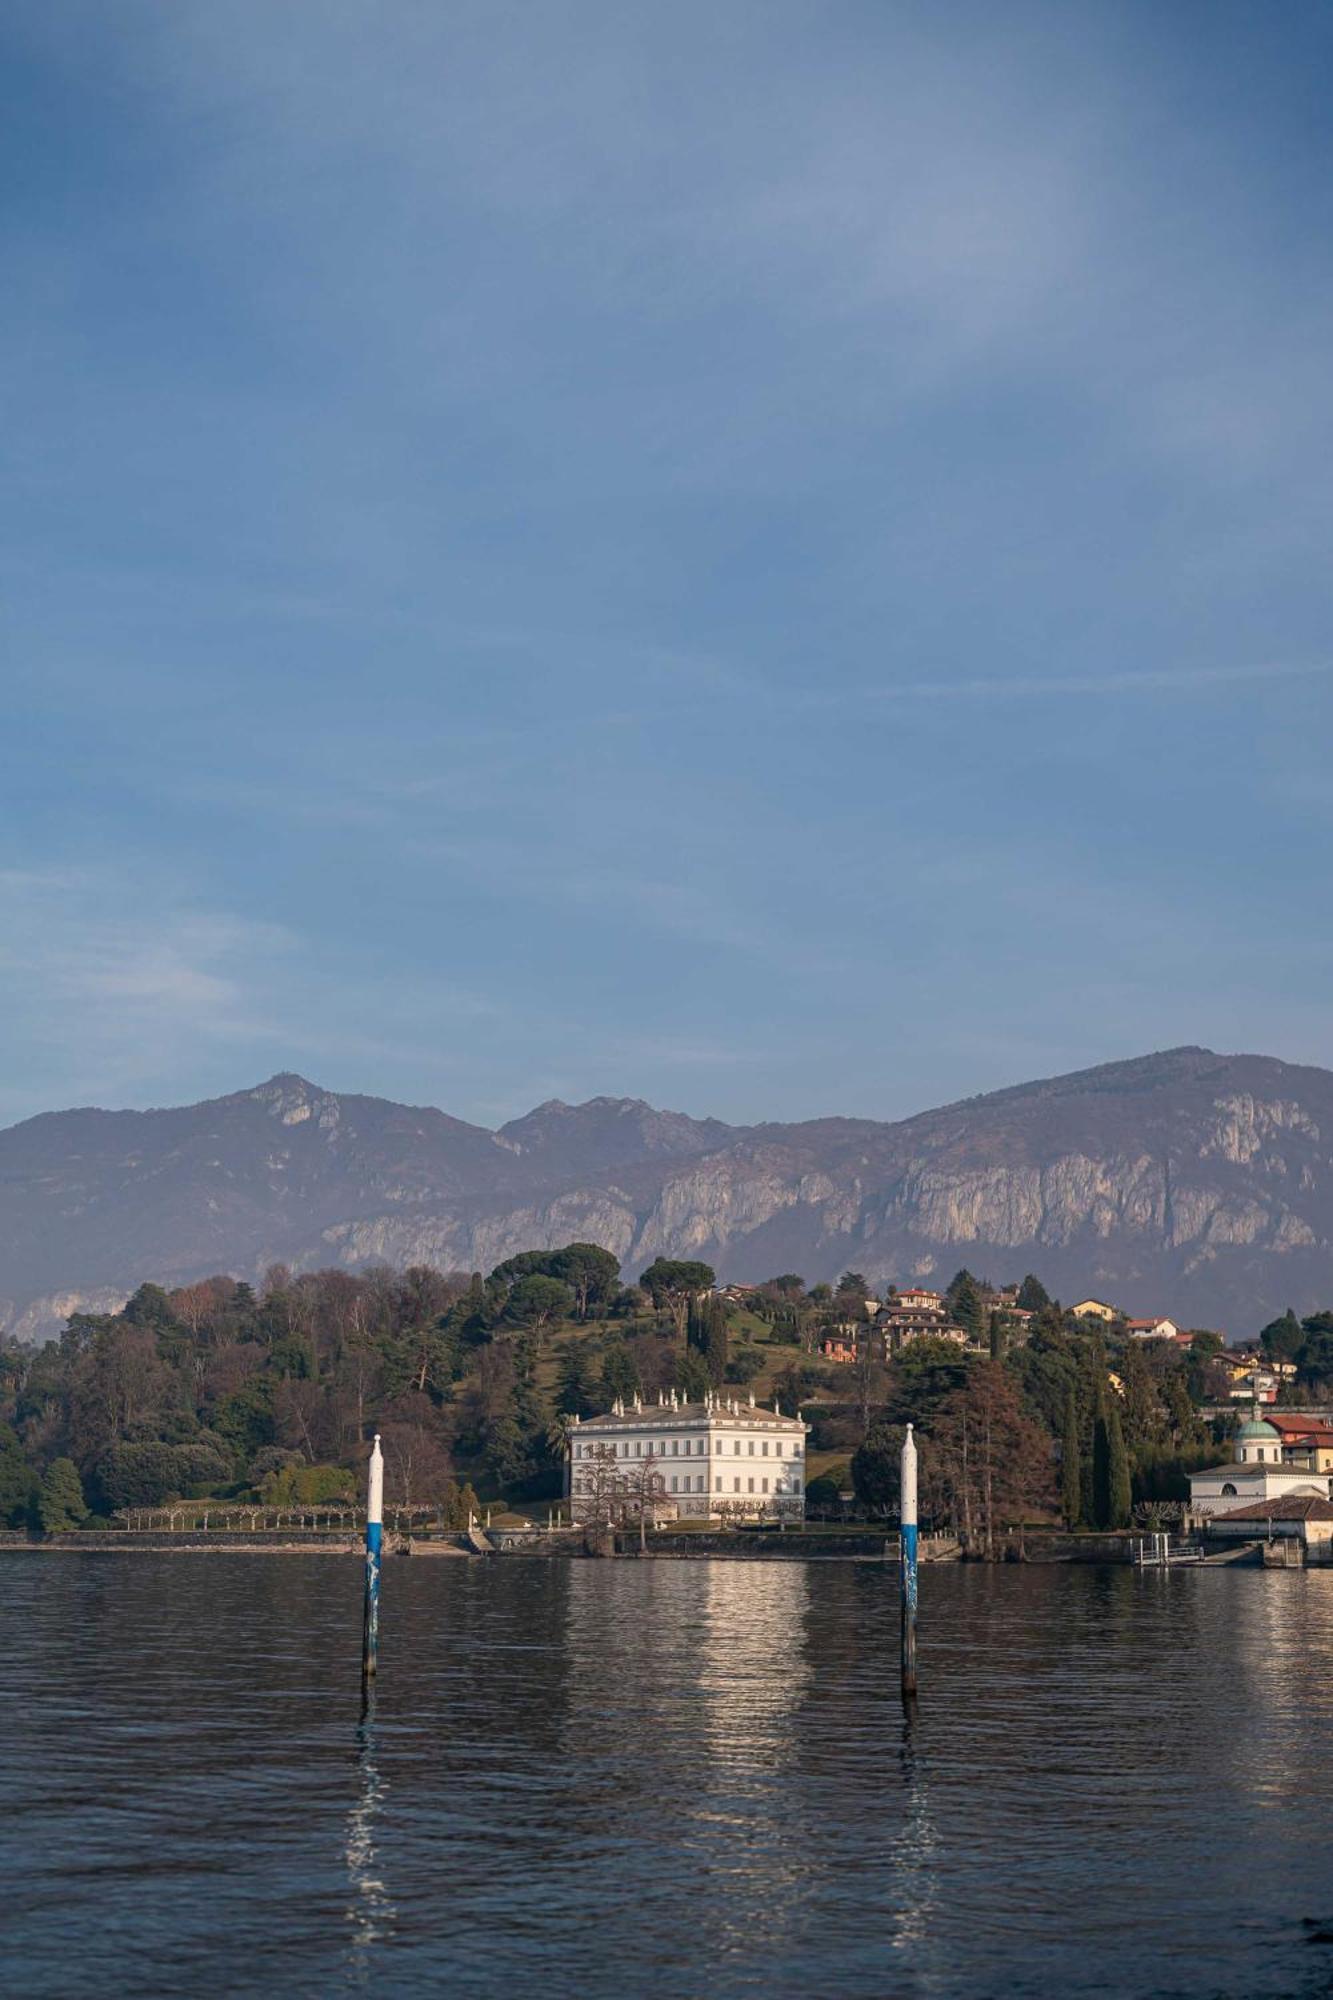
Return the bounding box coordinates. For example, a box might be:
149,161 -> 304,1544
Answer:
0,1244 -> 1333,1526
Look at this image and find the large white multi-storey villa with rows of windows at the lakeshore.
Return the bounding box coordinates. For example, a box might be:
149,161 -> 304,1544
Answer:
566,1390 -> 809,1520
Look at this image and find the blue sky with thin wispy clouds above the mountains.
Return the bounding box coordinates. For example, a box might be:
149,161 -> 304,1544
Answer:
0,0 -> 1333,1124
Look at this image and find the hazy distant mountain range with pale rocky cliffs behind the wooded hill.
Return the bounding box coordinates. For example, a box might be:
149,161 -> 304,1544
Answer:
0,1048 -> 1333,1336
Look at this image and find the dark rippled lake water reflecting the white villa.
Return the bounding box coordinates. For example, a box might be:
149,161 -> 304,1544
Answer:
0,1552 -> 1333,2000
